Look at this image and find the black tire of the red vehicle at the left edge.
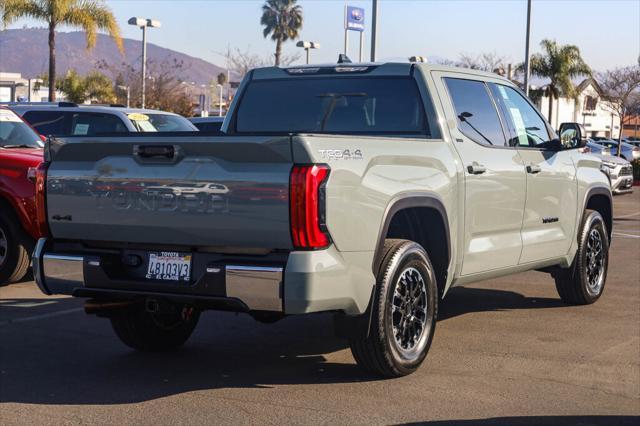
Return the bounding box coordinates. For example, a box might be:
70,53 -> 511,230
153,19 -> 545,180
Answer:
0,210 -> 30,286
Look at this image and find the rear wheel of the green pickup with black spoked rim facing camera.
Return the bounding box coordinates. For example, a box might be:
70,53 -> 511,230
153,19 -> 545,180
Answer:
349,239 -> 438,377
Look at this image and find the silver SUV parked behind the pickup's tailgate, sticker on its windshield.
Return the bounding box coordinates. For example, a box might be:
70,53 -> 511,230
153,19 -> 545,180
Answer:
8,102 -> 198,136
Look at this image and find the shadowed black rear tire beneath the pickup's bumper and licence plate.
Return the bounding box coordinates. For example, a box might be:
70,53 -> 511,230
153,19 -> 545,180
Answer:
110,305 -> 200,352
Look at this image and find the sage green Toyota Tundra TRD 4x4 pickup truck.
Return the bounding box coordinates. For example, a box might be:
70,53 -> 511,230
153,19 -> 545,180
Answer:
33,63 -> 612,377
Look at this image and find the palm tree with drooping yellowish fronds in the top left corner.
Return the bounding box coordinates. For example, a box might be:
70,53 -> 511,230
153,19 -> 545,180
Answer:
0,0 -> 123,102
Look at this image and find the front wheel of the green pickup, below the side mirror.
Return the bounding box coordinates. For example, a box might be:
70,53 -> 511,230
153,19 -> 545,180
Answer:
554,210 -> 609,305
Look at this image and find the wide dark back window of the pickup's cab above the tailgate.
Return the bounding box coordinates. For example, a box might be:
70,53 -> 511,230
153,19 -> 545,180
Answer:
235,77 -> 429,135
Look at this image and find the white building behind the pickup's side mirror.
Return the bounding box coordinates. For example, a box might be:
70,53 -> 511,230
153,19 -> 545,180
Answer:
537,78 -> 620,138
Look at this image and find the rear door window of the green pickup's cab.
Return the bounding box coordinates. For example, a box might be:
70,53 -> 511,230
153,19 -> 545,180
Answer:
445,78 -> 505,146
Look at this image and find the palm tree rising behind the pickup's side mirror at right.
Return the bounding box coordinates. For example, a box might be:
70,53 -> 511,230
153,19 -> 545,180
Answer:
531,39 -> 591,123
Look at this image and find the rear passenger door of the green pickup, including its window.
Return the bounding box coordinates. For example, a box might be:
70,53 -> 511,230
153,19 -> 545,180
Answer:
434,72 -> 526,275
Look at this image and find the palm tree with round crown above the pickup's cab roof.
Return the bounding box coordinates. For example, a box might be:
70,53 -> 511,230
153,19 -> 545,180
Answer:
260,0 -> 302,66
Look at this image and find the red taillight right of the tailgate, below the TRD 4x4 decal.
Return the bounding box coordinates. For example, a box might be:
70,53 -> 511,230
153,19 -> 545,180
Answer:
290,164 -> 330,249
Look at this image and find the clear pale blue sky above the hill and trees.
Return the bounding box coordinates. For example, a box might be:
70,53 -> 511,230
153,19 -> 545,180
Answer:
6,0 -> 640,70
